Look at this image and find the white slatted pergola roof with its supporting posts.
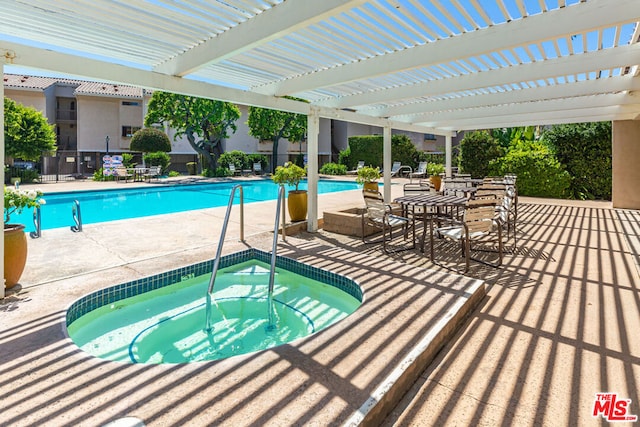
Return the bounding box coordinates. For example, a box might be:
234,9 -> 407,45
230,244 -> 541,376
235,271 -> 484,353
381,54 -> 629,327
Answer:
0,0 -> 640,296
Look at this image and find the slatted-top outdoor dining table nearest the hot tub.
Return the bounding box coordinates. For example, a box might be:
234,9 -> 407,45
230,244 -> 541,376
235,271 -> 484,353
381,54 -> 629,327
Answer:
394,194 -> 468,252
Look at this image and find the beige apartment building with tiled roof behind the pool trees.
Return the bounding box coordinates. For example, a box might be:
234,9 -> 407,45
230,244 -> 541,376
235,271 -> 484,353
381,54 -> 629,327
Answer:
4,74 -> 444,175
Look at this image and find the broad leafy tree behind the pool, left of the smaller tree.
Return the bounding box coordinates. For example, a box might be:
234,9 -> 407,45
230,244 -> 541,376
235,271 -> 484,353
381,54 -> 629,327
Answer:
144,91 -> 240,170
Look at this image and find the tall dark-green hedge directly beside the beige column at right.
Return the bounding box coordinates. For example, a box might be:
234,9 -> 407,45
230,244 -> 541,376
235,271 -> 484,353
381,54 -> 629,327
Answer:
543,122 -> 612,200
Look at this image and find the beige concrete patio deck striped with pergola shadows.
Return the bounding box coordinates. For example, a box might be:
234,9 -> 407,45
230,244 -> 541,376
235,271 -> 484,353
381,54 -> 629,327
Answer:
0,176 -> 640,426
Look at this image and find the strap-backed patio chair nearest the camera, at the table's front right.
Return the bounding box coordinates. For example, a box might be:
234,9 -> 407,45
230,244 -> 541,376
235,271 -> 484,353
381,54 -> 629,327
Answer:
430,199 -> 502,274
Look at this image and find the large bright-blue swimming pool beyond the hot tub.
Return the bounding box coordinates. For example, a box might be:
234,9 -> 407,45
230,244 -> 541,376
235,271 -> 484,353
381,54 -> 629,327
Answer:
11,179 -> 359,232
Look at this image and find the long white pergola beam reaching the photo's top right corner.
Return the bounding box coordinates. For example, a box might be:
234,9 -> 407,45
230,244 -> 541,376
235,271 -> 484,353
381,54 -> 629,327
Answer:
255,0 -> 640,95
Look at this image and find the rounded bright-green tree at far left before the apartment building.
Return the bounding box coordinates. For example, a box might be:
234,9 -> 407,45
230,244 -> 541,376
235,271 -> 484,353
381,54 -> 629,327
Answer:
4,97 -> 56,161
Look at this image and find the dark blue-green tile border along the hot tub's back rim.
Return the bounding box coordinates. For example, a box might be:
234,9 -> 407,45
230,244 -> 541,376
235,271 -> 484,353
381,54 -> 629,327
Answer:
67,248 -> 362,326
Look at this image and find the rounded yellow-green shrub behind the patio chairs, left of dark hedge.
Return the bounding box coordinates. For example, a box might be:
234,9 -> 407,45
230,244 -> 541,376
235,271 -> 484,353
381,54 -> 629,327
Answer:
489,142 -> 571,198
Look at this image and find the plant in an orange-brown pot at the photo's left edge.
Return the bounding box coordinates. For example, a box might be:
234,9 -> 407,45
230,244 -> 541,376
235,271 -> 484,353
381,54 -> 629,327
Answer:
4,186 -> 45,288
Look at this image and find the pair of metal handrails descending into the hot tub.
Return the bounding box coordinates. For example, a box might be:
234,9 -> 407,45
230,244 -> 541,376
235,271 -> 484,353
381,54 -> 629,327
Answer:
204,184 -> 286,332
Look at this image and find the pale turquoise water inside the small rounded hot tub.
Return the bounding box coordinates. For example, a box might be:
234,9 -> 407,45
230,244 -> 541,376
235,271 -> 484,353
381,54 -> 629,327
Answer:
68,259 -> 361,363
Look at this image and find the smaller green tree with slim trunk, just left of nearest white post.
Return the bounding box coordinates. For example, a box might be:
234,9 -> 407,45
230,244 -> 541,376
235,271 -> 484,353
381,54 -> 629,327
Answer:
247,98 -> 307,172
